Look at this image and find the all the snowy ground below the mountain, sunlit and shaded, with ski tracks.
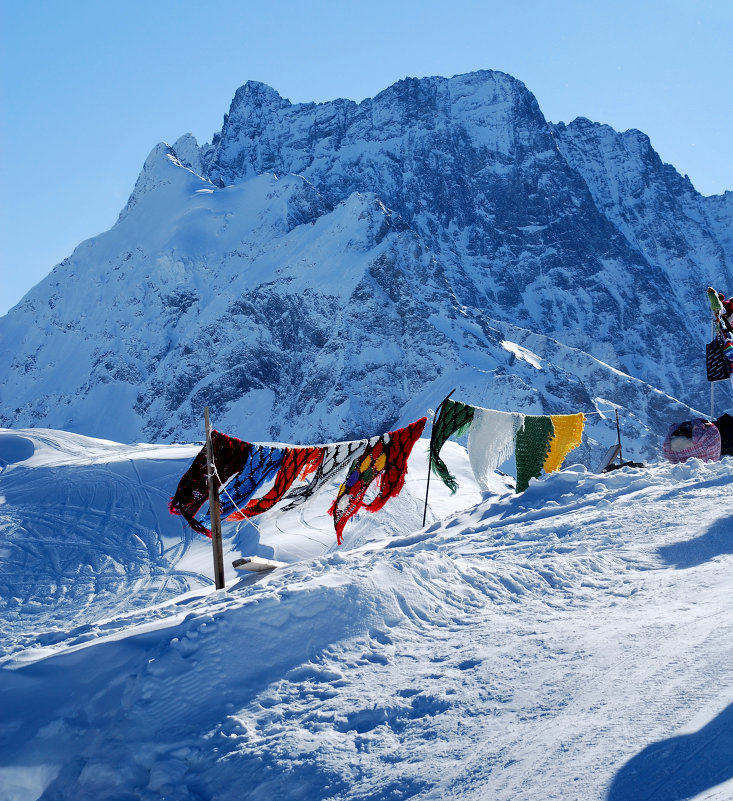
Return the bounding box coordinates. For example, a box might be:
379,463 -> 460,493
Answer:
0,430 -> 733,801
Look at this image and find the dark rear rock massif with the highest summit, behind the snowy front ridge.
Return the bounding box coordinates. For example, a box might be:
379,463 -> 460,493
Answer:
203,72 -> 733,404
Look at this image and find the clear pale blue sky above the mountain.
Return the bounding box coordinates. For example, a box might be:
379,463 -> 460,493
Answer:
0,0 -> 733,314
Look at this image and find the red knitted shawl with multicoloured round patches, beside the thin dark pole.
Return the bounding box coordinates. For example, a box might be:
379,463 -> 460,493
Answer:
330,417 -> 427,545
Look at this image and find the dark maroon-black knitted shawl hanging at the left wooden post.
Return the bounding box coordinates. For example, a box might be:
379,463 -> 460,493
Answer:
168,431 -> 252,537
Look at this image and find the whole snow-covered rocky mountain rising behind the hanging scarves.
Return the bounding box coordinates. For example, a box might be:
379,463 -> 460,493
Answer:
0,71 -> 733,457
